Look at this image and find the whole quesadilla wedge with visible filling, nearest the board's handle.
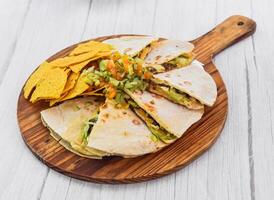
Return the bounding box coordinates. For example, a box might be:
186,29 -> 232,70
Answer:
145,40 -> 194,73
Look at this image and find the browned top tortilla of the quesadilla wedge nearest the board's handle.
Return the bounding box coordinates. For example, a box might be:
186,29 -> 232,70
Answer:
145,40 -> 194,65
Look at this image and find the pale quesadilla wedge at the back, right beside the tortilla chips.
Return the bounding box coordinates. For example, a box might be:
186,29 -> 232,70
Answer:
103,36 -> 158,57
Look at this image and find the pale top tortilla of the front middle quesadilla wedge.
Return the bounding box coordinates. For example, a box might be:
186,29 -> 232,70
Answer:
88,100 -> 164,157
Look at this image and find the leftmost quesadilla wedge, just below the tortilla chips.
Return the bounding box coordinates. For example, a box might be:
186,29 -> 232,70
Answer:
41,97 -> 108,158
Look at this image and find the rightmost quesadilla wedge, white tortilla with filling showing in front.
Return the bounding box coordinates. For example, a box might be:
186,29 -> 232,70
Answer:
149,61 -> 217,109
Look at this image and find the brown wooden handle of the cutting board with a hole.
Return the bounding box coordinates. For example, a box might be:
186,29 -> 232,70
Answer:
192,15 -> 256,64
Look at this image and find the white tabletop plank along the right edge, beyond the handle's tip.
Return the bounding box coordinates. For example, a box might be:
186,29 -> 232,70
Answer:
246,1 -> 274,200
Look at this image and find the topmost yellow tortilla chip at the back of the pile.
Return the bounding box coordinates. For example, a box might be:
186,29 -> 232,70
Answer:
69,41 -> 113,56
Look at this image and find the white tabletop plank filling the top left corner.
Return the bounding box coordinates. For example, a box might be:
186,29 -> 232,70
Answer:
0,0 -> 30,84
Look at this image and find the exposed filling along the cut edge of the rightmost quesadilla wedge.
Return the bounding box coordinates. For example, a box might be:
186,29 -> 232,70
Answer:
149,82 -> 203,109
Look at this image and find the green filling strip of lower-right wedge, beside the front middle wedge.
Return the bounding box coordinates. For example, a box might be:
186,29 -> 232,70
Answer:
128,99 -> 177,144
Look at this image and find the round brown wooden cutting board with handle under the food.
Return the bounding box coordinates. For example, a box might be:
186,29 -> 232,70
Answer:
17,16 -> 256,183
